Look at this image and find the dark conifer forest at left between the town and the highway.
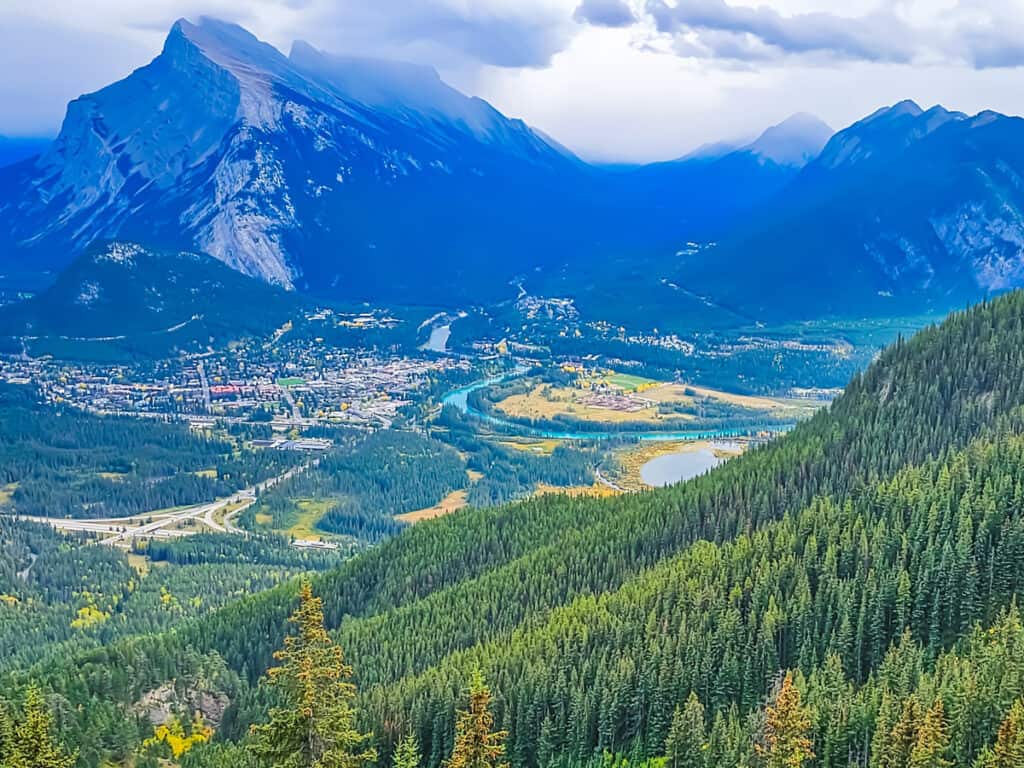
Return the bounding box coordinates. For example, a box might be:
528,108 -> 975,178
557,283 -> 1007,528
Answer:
0,384 -> 299,518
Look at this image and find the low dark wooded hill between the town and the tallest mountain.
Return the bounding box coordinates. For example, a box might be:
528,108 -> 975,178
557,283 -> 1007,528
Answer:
0,242 -> 302,354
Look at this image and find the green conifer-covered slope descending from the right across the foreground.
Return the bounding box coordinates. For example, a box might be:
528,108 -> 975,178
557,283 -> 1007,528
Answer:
4,293 -> 1024,768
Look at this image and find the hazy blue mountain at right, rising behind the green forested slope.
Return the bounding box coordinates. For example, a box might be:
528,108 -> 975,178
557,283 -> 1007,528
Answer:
680,101 -> 1024,317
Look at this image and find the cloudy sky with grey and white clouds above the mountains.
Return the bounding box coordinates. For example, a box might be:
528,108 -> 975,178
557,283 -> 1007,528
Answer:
0,0 -> 1024,161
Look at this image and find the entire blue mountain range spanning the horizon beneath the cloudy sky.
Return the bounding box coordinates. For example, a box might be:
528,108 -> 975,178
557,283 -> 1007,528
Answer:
0,18 -> 1024,322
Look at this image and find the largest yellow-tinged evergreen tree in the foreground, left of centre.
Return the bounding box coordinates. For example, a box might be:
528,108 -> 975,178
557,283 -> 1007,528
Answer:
252,582 -> 377,768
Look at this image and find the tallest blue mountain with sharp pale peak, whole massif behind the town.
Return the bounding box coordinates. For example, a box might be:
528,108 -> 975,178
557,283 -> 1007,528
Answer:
0,19 -> 585,303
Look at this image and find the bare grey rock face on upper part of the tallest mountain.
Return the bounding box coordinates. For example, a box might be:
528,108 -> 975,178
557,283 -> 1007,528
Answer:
0,19 -> 577,288
